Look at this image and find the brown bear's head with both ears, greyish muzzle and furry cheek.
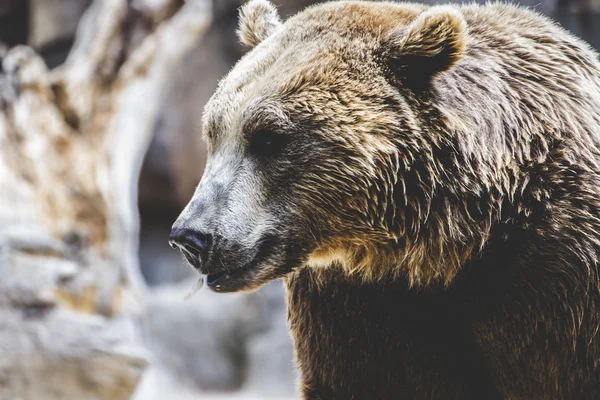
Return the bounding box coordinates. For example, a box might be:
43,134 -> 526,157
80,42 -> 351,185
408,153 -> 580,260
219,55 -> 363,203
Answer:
171,0 -> 472,292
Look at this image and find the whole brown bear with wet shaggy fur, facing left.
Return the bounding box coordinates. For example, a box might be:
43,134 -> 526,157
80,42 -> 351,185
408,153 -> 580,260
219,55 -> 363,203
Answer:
171,0 -> 600,400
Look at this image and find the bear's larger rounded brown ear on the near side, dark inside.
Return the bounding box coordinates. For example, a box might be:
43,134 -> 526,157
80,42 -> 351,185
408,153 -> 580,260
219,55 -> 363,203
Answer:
385,6 -> 467,84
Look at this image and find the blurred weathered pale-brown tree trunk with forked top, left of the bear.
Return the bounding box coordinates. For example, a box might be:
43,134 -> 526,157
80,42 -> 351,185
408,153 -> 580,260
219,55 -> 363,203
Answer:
0,0 -> 210,399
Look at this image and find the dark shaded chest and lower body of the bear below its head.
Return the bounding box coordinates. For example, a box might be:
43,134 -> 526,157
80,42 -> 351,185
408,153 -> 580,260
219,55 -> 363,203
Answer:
287,247 -> 600,400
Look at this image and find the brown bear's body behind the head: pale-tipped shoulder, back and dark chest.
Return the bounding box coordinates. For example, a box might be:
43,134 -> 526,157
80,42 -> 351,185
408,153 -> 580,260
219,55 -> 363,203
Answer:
286,4 -> 600,400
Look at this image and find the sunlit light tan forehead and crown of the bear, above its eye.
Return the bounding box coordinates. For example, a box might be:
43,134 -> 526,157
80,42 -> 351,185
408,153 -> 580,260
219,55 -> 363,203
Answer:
203,1 -> 426,142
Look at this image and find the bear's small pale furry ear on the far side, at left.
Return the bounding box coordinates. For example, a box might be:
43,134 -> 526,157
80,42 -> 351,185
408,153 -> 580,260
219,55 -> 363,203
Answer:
237,0 -> 282,48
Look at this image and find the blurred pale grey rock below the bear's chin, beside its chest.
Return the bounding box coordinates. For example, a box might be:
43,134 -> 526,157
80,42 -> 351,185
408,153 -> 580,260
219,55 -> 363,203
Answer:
136,277 -> 296,400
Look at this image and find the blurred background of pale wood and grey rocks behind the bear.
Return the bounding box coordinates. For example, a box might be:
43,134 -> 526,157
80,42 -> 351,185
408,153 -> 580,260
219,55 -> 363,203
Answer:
0,0 -> 600,400
